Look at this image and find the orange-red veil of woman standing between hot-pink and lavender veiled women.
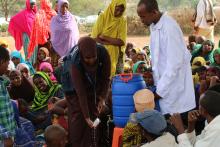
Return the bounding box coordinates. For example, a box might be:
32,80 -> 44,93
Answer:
28,0 -> 56,57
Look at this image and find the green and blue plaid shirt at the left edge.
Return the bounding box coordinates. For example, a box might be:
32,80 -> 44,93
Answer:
0,77 -> 16,140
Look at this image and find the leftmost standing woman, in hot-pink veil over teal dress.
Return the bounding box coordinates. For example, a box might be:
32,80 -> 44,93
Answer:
8,0 -> 37,63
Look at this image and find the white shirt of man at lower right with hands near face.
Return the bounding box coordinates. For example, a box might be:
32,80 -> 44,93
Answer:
178,115 -> 220,147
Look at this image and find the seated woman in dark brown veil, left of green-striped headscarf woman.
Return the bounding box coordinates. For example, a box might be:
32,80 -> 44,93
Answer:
8,70 -> 35,103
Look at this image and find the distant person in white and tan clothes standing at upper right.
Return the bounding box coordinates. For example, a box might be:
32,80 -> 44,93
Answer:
193,0 -> 217,42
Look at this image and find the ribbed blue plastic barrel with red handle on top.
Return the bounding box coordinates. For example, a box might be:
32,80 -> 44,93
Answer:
112,74 -> 146,128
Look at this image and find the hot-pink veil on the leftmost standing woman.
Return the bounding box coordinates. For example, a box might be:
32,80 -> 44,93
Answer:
8,0 -> 37,50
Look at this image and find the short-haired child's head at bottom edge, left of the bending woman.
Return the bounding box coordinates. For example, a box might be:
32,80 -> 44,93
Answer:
44,125 -> 67,147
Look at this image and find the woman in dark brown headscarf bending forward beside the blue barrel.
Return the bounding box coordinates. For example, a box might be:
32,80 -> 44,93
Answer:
65,37 -> 111,147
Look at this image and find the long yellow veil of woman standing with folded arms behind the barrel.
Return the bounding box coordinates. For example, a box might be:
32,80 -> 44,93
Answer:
91,0 -> 127,76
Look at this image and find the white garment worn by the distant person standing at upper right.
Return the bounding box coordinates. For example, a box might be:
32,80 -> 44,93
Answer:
195,0 -> 214,30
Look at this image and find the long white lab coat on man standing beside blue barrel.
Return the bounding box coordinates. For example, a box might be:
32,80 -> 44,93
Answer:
150,14 -> 196,114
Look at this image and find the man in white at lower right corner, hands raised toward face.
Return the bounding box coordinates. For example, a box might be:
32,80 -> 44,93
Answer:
170,90 -> 220,147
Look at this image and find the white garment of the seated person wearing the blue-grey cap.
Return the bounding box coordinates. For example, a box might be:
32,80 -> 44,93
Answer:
141,133 -> 178,147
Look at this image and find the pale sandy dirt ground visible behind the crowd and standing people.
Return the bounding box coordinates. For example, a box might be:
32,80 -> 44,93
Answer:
0,34 -> 220,51
